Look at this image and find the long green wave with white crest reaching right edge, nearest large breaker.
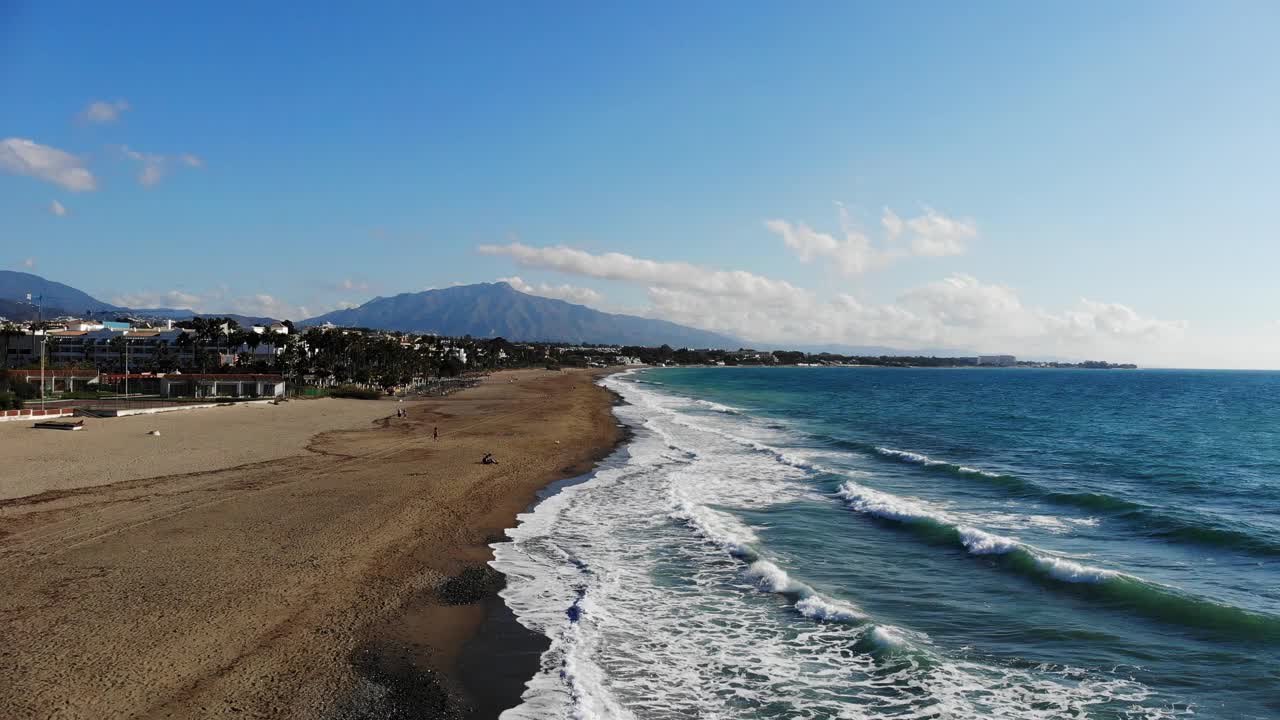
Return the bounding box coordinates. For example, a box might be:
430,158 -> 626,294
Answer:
836,482 -> 1280,641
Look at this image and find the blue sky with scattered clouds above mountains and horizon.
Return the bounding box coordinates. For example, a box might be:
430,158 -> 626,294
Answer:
0,1 -> 1280,368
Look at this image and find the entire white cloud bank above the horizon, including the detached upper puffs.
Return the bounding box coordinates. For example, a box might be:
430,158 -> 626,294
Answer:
476,205 -> 1188,360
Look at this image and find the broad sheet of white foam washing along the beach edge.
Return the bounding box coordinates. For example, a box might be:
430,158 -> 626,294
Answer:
494,377 -> 1177,720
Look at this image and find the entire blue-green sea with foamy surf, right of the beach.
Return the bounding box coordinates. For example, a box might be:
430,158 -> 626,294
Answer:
483,368 -> 1280,720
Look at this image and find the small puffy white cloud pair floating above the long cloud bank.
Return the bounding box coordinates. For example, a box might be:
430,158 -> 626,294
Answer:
764,202 -> 978,275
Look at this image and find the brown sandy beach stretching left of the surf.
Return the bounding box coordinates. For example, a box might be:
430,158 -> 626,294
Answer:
0,370 -> 618,719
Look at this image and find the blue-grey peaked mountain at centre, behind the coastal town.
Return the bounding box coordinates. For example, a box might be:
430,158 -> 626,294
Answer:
298,282 -> 742,348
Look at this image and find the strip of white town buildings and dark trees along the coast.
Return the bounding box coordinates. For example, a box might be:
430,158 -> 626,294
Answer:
0,308 -> 1134,397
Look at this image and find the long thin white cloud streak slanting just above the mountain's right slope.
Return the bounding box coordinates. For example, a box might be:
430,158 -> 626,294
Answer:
477,242 -> 805,302
